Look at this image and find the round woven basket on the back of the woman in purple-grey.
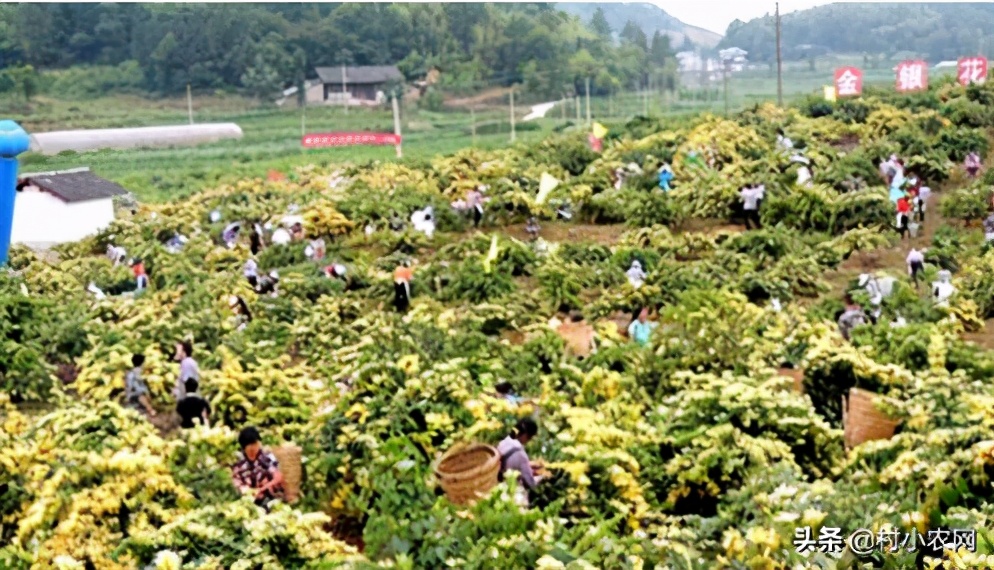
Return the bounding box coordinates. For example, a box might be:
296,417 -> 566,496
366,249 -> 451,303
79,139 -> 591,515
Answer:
435,443 -> 500,505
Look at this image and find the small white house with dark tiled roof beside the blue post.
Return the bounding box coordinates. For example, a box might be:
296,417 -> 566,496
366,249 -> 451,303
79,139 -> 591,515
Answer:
10,164 -> 127,247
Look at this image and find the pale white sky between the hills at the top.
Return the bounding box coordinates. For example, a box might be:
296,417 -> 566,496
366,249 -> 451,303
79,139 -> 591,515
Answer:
652,0 -> 976,35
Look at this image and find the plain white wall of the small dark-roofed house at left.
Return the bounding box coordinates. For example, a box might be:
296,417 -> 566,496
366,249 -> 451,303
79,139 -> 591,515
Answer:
10,189 -> 114,244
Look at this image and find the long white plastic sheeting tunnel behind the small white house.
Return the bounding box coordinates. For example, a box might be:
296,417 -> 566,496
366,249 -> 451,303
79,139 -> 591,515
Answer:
31,123 -> 242,154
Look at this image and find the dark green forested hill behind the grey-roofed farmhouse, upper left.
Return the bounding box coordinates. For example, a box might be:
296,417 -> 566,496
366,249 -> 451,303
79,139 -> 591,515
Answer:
0,3 -> 673,97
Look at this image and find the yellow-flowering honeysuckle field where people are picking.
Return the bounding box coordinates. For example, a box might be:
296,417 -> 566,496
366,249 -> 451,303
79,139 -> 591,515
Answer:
0,76 -> 994,570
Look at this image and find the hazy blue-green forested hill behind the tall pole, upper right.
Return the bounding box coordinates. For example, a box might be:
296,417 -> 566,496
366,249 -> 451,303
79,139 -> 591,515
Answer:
720,3 -> 994,63
